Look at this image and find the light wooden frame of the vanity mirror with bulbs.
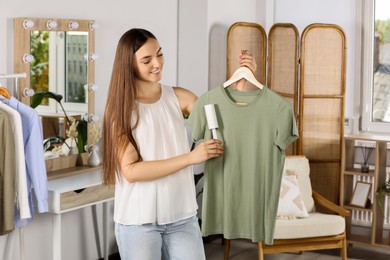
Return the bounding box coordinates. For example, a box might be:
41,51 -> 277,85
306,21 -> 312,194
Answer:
14,17 -> 96,143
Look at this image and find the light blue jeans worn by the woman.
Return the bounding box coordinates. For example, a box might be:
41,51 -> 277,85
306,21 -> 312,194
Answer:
115,216 -> 206,260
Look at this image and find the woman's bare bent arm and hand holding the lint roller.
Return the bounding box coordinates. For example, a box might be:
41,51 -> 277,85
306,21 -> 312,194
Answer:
121,139 -> 224,182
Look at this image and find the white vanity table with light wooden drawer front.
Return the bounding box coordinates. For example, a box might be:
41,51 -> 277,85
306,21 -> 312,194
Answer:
48,166 -> 114,260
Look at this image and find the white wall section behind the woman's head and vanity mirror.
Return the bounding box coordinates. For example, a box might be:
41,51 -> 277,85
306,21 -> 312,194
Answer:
0,0 -> 178,120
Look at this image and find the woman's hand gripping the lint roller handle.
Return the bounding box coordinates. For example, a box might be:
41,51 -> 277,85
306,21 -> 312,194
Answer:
190,139 -> 225,164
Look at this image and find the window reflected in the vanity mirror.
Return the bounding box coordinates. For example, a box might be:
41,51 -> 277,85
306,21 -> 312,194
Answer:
31,31 -> 88,114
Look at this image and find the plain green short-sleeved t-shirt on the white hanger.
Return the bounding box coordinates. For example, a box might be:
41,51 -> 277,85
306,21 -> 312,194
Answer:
188,86 -> 298,244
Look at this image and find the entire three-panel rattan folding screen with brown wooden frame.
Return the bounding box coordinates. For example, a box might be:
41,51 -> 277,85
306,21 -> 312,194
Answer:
227,22 -> 346,203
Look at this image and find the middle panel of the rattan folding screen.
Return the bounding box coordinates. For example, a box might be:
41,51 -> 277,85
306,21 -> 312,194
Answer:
267,23 -> 299,155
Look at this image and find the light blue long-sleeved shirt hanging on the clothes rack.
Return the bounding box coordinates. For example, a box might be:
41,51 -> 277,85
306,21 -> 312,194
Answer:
8,97 -> 48,227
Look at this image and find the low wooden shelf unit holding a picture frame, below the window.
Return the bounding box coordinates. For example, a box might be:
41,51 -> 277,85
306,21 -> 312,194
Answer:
340,133 -> 390,249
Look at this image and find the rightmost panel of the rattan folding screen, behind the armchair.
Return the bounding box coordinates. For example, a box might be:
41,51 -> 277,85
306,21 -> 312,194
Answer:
298,23 -> 346,207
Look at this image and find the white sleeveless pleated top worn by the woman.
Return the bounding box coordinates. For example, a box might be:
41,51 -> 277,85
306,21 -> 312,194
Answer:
114,85 -> 198,225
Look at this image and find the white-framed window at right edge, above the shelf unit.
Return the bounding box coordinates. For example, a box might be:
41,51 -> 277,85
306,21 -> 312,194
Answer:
361,0 -> 390,132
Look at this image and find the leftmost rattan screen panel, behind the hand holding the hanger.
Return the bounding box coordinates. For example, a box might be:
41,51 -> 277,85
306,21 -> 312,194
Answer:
226,22 -> 267,85
